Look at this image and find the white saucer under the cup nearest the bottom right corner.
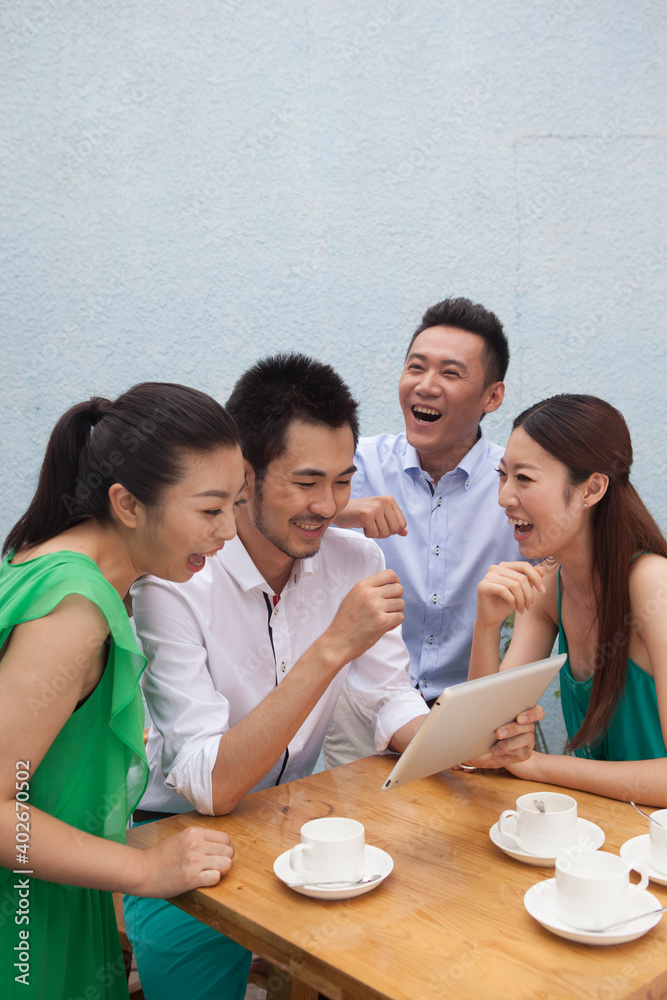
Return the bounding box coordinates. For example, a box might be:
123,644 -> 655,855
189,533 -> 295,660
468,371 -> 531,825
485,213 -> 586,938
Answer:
523,878 -> 662,944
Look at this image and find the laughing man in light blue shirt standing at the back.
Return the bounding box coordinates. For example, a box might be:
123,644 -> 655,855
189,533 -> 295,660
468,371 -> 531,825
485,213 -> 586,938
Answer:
325,298 -> 520,767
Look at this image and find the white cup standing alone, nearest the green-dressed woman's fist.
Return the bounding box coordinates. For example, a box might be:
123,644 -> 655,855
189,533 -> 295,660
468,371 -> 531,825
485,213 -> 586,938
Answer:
289,816 -> 364,882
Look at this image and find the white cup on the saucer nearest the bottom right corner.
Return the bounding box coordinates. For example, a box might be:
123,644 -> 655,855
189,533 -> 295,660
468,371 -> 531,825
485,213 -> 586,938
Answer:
556,851 -> 648,930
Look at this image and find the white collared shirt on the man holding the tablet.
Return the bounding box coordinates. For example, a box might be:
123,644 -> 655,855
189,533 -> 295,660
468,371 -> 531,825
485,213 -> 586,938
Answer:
132,528 -> 428,814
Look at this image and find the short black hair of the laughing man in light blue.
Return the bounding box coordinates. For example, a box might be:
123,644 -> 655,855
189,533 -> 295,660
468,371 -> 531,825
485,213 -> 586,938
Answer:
405,298 -> 510,385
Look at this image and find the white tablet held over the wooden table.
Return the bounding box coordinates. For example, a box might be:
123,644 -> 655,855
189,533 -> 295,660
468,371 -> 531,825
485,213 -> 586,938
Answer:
382,654 -> 567,788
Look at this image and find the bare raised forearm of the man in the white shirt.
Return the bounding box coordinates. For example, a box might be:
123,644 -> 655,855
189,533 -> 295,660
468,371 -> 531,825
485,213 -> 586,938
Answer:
212,639 -> 347,816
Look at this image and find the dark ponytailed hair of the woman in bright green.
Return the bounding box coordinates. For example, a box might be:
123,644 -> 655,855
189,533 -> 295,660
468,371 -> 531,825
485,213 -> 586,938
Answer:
3,382 -> 238,554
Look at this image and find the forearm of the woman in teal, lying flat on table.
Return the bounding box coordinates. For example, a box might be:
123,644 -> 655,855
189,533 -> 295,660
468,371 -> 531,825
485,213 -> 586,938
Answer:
510,753 -> 667,808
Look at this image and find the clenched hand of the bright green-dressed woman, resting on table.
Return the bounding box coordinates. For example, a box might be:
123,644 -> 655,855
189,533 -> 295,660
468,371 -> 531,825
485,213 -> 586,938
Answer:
134,826 -> 234,899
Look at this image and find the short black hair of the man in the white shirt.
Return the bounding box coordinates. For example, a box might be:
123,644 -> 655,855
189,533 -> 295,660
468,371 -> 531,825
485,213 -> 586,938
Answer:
226,354 -> 359,480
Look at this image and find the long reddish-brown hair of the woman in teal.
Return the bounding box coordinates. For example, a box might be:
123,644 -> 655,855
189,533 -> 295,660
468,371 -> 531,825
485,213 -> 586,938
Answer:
512,394 -> 667,750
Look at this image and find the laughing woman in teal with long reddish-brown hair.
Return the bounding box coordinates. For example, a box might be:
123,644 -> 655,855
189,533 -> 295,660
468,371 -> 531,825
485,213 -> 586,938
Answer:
469,395 -> 667,806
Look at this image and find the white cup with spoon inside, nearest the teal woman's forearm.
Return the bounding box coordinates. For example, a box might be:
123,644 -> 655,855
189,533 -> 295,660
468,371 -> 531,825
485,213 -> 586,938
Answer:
498,791 -> 577,858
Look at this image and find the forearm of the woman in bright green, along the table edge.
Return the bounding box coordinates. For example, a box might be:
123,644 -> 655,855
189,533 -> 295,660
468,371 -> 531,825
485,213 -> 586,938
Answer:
0,800 -> 144,894
